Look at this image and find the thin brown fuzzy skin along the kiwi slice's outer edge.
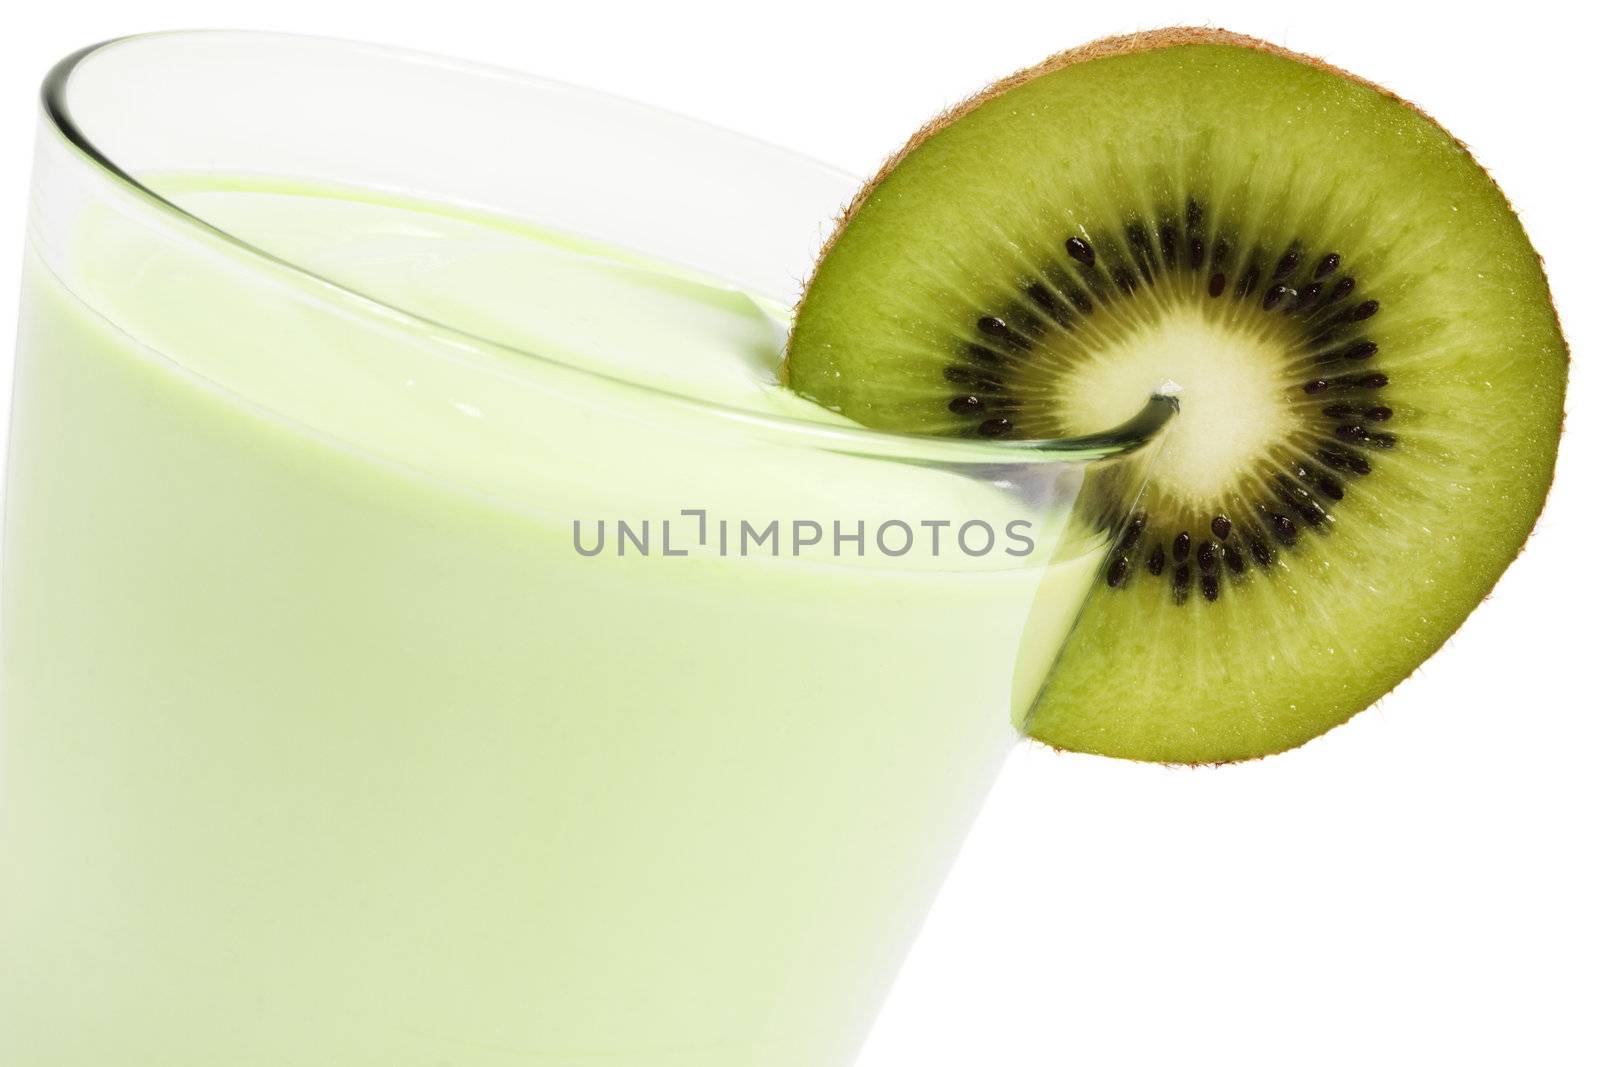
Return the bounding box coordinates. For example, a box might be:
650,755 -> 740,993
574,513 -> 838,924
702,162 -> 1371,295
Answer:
779,26 -> 1571,766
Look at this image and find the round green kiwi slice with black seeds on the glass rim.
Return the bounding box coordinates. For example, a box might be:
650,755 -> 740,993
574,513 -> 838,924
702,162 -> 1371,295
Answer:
786,29 -> 1566,763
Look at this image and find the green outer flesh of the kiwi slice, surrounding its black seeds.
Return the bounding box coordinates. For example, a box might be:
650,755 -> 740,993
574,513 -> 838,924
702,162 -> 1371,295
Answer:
784,27 -> 1566,763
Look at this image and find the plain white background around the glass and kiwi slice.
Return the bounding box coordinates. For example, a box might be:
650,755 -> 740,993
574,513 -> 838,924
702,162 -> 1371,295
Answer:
0,0 -> 1600,1067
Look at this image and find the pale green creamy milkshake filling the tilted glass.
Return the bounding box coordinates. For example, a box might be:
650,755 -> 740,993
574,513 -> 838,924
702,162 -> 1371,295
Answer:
0,163 -> 1139,1067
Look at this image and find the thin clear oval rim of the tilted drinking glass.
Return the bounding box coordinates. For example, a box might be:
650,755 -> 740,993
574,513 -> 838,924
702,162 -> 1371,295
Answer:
40,29 -> 1179,464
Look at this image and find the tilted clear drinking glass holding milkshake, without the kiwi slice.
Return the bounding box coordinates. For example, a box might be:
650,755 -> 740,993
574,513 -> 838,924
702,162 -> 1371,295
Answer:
0,32 -> 1173,1067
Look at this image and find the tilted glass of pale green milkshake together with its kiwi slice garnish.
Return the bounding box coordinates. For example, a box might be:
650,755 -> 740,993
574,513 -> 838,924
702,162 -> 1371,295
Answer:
0,18 -> 1568,1067
